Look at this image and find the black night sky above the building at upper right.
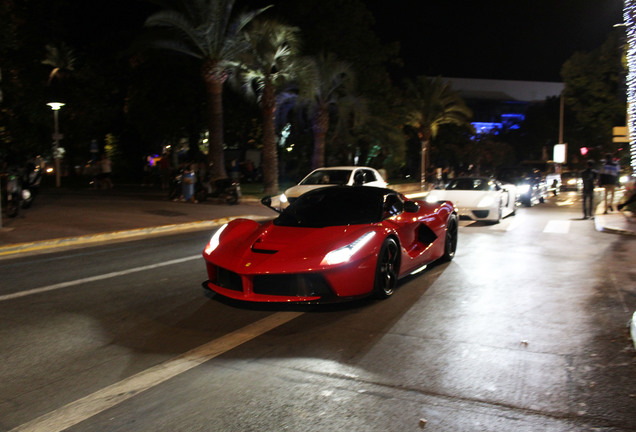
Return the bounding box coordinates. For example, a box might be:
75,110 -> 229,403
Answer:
365,0 -> 623,81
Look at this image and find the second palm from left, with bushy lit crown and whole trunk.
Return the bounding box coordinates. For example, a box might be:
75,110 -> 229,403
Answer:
239,20 -> 300,195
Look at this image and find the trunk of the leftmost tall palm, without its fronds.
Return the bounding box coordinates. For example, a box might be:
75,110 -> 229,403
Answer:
203,71 -> 227,180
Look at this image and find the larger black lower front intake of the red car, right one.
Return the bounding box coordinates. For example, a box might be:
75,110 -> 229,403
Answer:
254,274 -> 332,299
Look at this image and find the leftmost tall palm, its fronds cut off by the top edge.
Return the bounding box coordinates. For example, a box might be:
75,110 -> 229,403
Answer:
146,0 -> 269,179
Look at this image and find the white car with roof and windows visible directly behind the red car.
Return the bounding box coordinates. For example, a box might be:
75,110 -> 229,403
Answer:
280,166 -> 386,206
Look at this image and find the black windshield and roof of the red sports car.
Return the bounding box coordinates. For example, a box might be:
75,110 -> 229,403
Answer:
274,186 -> 386,228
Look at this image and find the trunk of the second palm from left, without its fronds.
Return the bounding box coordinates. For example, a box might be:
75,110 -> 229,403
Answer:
261,79 -> 278,195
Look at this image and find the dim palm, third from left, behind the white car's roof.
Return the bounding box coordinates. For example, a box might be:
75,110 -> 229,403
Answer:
300,54 -> 355,169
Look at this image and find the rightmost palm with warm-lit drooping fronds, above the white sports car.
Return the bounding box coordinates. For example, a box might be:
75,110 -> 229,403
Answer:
405,76 -> 473,188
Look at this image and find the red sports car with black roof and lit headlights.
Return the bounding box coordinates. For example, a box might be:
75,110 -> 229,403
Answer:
203,186 -> 458,302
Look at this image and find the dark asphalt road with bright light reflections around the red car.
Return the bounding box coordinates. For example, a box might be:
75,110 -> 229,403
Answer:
0,194 -> 636,432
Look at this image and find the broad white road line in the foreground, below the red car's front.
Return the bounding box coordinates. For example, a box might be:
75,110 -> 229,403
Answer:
10,312 -> 304,432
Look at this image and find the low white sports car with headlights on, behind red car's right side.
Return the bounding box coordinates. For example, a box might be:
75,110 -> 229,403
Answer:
426,177 -> 517,223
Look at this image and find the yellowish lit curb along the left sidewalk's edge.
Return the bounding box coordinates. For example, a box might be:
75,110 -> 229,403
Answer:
0,215 -> 269,259
